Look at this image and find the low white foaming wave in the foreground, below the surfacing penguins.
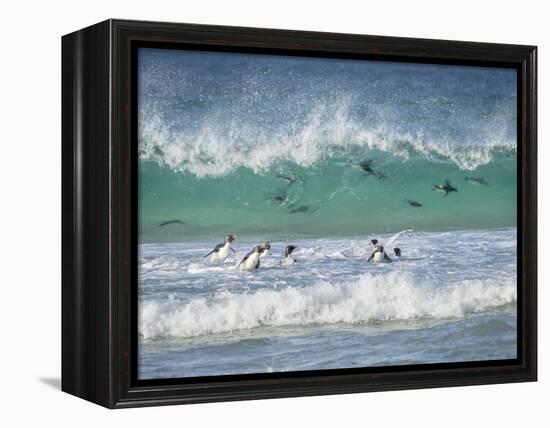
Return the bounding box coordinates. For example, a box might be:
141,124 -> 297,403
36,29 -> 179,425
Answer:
138,272 -> 517,339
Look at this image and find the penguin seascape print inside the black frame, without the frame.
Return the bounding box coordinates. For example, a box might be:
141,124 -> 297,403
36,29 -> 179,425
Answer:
137,48 -> 518,379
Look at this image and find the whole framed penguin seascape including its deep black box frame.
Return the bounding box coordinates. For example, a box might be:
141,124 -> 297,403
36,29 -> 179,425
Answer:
62,20 -> 537,408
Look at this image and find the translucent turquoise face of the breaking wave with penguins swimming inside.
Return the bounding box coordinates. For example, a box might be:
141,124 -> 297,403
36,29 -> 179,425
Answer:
139,152 -> 516,242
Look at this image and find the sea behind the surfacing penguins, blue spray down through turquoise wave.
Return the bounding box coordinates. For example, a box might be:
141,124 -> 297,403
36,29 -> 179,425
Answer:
138,49 -> 517,242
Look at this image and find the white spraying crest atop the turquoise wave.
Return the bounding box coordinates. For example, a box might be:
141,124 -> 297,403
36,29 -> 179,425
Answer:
139,103 -> 516,178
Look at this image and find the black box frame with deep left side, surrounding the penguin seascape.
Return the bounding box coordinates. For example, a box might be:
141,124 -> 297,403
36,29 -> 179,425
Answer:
62,20 -> 537,408
